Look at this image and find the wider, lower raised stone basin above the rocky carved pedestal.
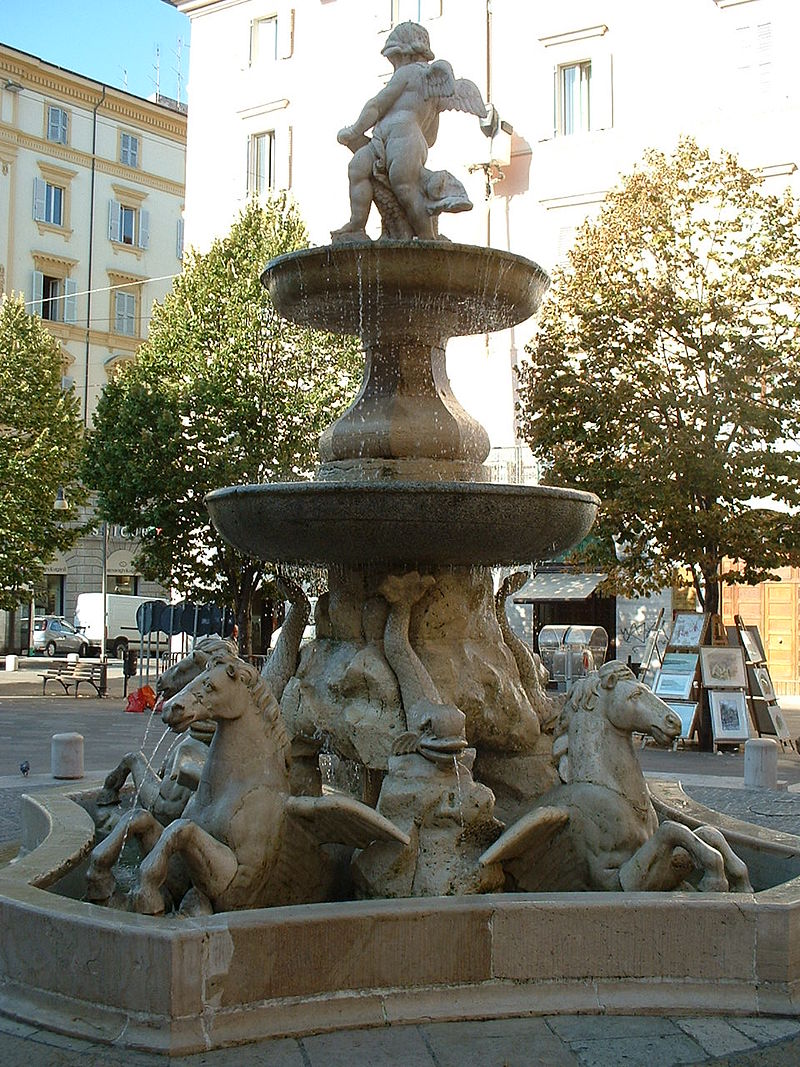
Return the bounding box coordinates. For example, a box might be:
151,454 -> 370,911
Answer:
206,482 -> 599,567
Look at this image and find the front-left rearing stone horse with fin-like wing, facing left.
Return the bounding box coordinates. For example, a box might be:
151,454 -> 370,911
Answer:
86,652 -> 407,914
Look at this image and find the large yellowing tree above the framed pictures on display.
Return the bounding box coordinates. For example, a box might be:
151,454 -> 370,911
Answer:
519,139 -> 800,612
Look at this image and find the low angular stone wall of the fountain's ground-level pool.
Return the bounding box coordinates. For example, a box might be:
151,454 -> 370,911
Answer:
0,783 -> 800,1055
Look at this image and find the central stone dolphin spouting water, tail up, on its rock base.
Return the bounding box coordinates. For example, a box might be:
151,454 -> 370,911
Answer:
353,572 -> 503,897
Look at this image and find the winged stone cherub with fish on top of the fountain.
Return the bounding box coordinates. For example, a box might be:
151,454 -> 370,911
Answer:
331,22 -> 486,243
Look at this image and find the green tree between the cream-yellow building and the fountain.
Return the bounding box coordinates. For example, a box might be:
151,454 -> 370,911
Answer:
85,196 -> 361,652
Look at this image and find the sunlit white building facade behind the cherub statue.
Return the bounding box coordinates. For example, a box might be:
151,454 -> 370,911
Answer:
173,0 -> 800,684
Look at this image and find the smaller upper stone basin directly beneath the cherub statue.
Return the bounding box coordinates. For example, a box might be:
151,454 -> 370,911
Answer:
261,240 -> 549,340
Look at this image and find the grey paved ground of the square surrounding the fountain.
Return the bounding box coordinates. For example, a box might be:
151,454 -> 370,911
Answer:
0,660 -> 800,1067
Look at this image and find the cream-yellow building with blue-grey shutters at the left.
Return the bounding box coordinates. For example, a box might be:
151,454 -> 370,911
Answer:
0,45 -> 187,649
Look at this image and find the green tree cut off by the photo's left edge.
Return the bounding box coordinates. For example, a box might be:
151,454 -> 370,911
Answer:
0,296 -> 86,610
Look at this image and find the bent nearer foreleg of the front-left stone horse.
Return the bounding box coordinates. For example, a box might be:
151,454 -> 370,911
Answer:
130,818 -> 239,915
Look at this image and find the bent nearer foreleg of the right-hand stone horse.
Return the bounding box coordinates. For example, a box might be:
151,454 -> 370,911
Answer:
620,821 -> 727,893
